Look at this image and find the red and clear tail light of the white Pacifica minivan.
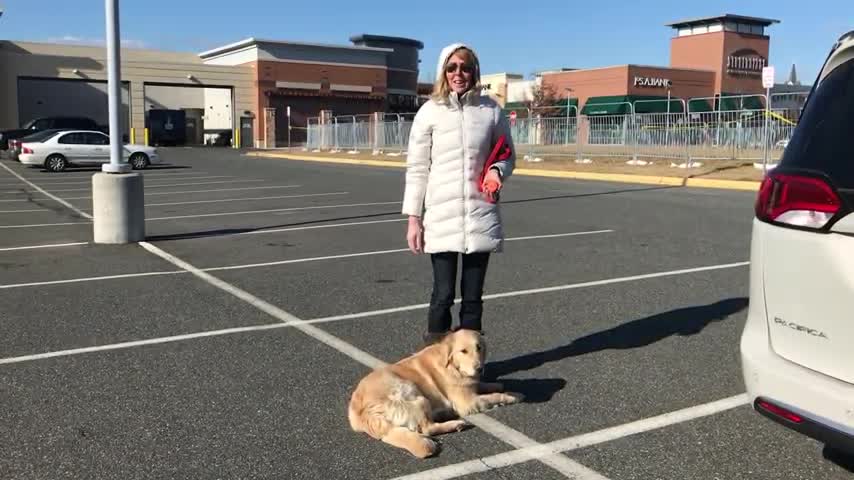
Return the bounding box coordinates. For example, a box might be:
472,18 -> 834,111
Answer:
756,173 -> 842,229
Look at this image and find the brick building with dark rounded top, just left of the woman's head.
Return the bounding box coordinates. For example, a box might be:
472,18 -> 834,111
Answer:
199,35 -> 423,147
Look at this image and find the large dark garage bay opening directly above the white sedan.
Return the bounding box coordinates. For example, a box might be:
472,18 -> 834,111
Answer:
18,78 -> 130,135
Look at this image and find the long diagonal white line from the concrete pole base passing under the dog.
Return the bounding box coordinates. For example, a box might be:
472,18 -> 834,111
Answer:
140,242 -> 596,480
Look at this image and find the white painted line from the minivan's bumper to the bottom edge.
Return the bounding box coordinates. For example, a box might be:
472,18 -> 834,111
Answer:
394,394 -> 750,480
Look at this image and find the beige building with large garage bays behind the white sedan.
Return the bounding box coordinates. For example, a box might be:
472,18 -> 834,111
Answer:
0,41 -> 258,145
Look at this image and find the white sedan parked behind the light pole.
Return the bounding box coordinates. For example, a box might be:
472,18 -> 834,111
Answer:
18,130 -> 161,172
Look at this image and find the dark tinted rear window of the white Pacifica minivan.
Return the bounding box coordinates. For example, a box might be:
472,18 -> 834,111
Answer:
780,60 -> 854,189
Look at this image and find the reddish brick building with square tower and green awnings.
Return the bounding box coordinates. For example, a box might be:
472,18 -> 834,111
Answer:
505,14 -> 778,115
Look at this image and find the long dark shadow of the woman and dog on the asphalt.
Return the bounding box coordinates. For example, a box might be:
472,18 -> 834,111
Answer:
485,297 -> 748,403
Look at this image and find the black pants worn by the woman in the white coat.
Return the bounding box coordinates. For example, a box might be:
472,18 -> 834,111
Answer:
427,252 -> 489,333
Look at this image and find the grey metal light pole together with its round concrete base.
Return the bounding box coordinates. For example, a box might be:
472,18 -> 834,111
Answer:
92,0 -> 145,244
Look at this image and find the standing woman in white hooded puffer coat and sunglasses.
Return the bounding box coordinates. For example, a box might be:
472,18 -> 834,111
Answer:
403,43 -> 516,342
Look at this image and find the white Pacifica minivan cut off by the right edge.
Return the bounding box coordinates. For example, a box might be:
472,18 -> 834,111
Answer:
740,31 -> 854,454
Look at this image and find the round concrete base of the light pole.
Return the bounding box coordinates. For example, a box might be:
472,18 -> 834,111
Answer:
92,172 -> 145,244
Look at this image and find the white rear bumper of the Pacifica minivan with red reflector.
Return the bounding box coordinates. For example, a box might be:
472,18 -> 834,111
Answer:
741,308 -> 854,454
